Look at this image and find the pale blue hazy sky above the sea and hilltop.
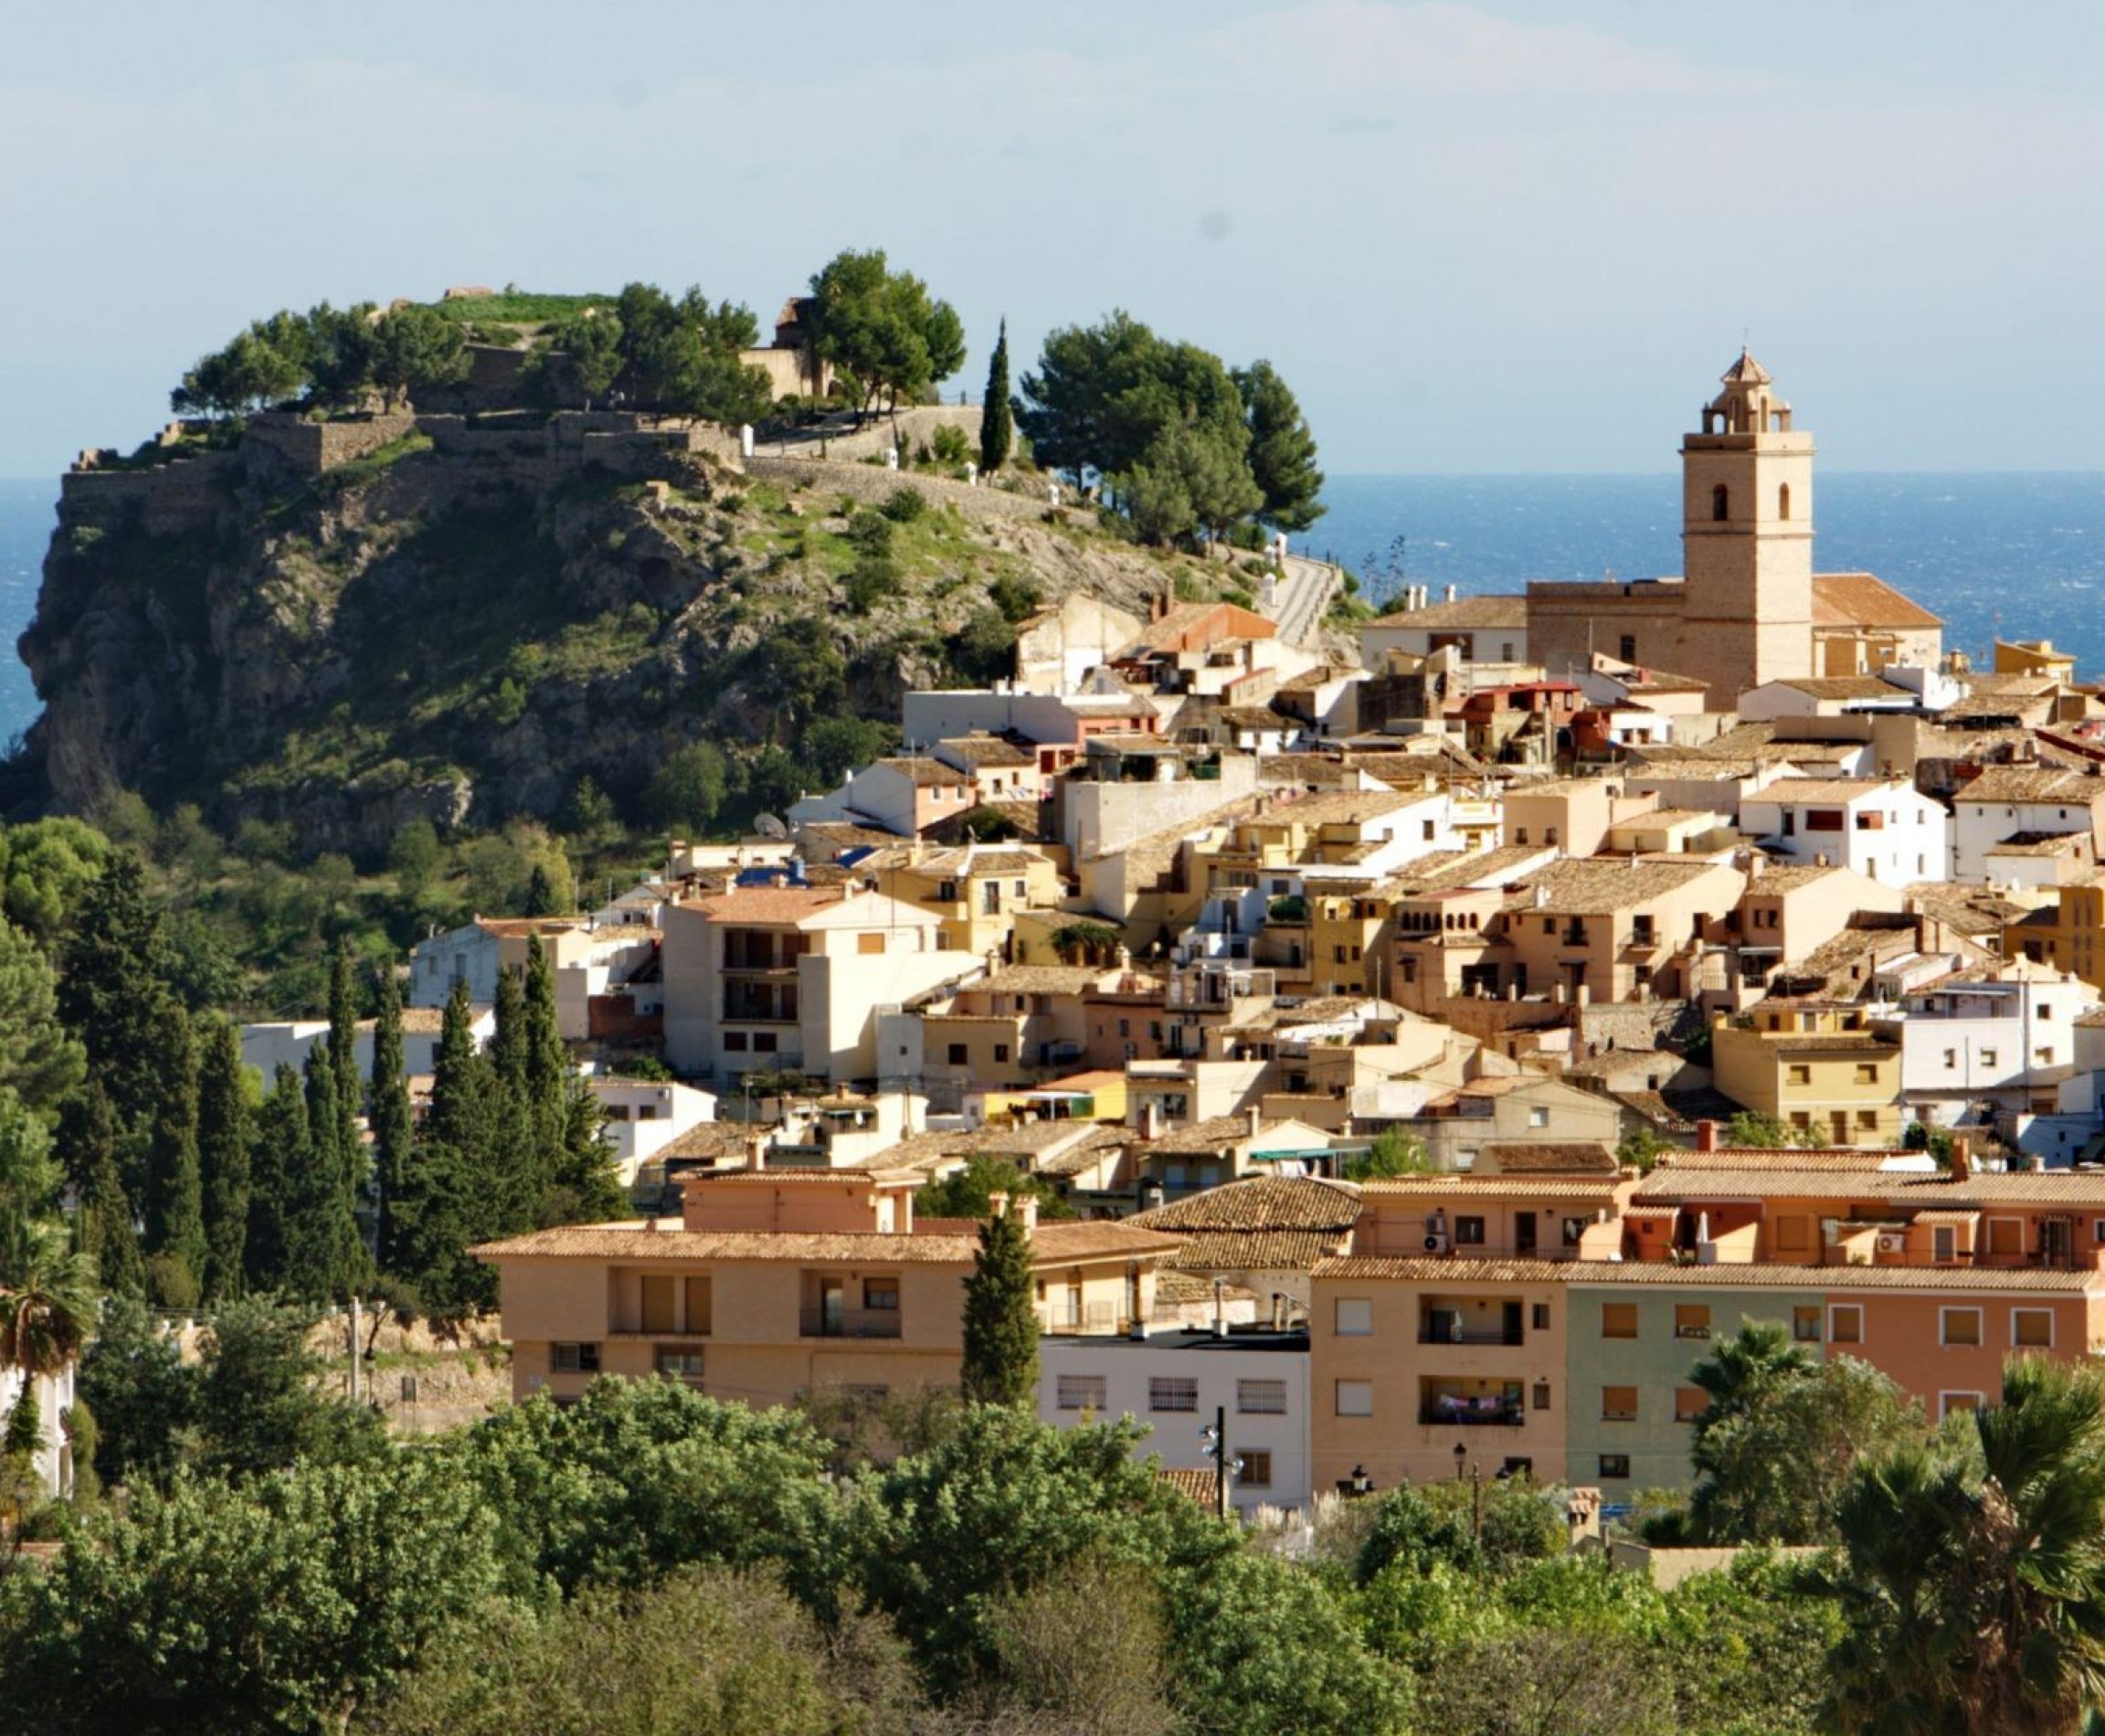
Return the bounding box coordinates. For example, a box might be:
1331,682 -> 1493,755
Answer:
0,0 -> 2105,475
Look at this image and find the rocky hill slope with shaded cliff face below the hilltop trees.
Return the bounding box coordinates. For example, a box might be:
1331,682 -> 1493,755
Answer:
21,412 -> 1233,854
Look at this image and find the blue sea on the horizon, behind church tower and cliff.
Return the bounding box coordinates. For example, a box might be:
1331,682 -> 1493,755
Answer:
0,471 -> 2105,743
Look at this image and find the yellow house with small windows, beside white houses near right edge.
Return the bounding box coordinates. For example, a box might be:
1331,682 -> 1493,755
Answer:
1711,1001 -> 1901,1149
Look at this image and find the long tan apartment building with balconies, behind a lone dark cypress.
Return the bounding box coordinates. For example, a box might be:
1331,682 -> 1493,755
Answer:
473,1170 -> 1179,1405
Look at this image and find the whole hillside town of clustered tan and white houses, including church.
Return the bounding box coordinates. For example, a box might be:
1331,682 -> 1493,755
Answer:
164,354 -> 2105,1517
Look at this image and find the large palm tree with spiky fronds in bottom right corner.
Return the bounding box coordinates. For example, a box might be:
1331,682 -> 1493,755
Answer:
1825,1360 -> 2105,1736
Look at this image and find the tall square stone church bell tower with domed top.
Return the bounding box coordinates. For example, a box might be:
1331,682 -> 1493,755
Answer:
1680,349 -> 1814,711
